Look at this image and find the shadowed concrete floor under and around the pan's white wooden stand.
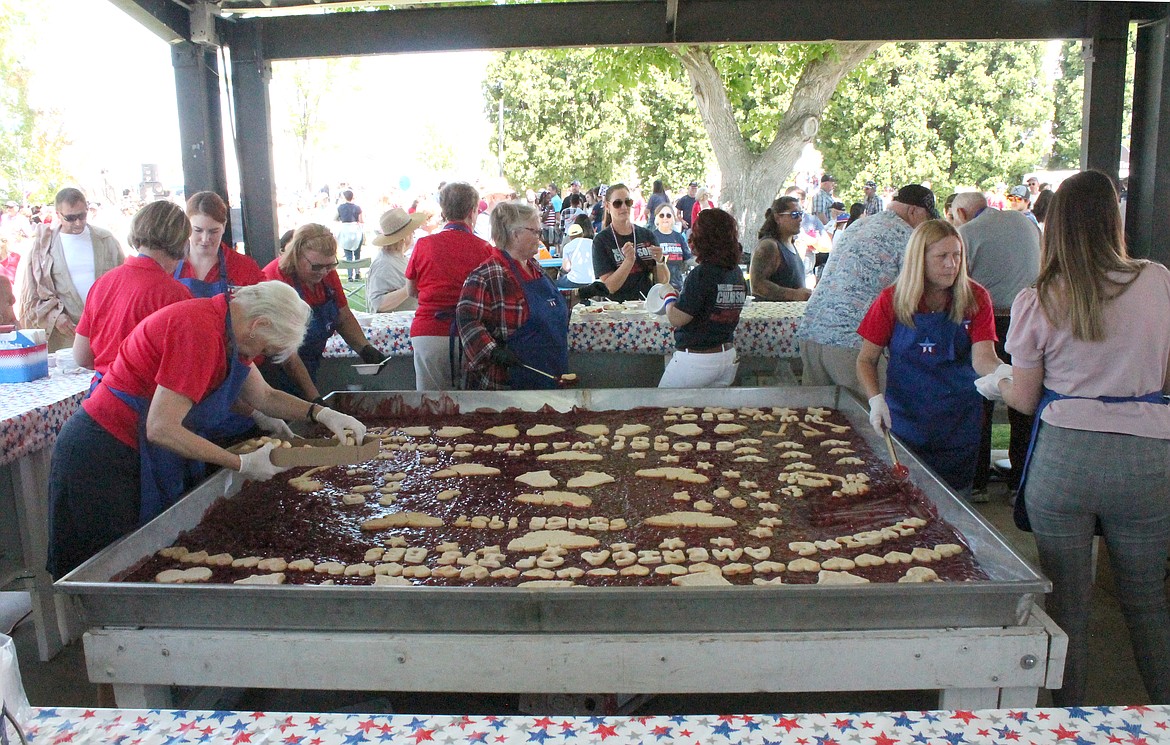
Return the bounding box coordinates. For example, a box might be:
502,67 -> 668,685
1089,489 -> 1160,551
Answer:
6,483 -> 1149,715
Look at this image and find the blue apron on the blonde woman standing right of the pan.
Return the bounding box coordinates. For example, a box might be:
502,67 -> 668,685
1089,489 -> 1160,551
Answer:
886,312 -> 983,489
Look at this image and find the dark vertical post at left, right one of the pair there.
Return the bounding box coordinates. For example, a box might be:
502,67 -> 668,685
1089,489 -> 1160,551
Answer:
228,23 -> 277,267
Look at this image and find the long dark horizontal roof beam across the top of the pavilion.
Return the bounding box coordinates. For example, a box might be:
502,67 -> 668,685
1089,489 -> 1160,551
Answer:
253,0 -> 1104,60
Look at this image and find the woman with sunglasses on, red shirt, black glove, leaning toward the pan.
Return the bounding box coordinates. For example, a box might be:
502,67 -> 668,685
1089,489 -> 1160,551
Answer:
263,222 -> 385,401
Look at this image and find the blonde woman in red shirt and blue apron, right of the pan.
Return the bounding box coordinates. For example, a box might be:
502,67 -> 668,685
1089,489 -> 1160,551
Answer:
858,220 -> 1000,492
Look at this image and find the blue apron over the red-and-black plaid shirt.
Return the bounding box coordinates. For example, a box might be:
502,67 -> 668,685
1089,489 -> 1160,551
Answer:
501,251 -> 569,391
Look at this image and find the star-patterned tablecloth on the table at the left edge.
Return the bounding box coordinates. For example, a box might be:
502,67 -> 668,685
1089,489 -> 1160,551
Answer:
0,368 -> 94,465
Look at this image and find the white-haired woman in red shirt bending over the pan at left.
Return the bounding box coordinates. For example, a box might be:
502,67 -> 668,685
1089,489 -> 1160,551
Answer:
49,282 -> 365,577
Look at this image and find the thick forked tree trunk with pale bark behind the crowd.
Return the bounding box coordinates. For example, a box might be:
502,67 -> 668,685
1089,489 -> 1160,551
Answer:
673,42 -> 882,246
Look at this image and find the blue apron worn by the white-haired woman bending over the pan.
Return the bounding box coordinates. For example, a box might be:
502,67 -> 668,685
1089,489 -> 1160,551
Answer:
108,301 -> 252,524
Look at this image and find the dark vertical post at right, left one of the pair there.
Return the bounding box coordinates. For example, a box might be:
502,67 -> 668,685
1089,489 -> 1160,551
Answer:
1081,4 -> 1129,179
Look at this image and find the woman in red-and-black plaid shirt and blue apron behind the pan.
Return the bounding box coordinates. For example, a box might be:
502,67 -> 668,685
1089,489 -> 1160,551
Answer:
455,202 -> 569,391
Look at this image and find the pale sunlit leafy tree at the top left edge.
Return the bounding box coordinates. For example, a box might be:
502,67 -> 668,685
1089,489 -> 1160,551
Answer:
0,0 -> 68,202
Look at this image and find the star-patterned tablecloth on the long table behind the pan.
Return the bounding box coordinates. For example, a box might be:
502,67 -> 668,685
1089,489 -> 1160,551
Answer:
325,302 -> 805,358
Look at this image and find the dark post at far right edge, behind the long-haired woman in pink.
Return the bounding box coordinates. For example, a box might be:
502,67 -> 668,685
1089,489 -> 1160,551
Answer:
1126,20 -> 1170,264
